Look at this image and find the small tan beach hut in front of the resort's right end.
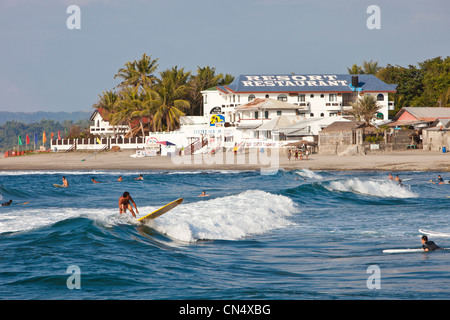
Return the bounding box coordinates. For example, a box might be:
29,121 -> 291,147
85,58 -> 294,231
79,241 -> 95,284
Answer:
319,121 -> 364,155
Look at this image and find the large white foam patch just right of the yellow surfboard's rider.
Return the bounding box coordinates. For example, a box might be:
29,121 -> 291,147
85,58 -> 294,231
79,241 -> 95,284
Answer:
148,190 -> 298,242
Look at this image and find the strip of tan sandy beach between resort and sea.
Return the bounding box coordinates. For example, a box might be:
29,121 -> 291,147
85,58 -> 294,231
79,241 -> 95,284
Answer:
0,150 -> 450,172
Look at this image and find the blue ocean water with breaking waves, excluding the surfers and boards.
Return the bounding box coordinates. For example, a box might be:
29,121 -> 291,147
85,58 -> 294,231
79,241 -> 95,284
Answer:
0,170 -> 450,300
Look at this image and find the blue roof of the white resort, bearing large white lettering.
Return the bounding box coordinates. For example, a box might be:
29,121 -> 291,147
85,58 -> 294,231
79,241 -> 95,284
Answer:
217,74 -> 397,93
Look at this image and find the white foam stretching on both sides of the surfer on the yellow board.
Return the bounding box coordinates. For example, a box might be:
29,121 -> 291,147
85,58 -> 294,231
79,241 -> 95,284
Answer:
0,190 -> 298,242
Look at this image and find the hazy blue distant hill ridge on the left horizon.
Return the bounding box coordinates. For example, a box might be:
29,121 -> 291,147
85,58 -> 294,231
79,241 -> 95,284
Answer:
0,111 -> 92,125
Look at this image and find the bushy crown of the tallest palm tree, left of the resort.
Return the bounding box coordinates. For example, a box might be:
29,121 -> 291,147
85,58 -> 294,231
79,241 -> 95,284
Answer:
114,53 -> 158,88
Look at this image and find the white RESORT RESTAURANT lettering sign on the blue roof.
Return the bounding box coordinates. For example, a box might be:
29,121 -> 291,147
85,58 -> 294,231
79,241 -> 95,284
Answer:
240,74 -> 349,90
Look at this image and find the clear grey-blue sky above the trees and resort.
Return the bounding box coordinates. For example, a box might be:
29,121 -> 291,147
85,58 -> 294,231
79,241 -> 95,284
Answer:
0,0 -> 450,112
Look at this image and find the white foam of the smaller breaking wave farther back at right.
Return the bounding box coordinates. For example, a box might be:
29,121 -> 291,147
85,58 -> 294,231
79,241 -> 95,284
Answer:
325,178 -> 418,198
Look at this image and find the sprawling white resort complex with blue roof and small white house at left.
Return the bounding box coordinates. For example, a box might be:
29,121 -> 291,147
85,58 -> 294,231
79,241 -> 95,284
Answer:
52,74 -> 396,154
